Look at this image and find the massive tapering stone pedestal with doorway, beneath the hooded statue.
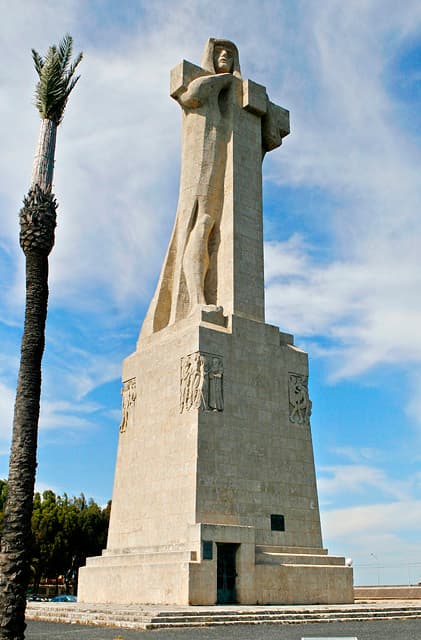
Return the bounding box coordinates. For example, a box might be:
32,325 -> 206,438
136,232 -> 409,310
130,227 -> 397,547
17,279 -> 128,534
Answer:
78,308 -> 353,605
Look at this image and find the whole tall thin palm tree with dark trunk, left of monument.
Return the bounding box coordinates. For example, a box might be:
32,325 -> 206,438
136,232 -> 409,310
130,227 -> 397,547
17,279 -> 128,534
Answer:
0,35 -> 82,640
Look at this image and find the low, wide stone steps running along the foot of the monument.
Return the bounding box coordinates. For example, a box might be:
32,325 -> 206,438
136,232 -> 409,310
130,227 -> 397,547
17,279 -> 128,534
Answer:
26,601 -> 421,630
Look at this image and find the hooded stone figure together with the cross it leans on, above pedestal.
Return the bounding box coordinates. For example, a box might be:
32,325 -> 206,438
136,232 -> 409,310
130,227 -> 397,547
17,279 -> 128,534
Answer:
142,38 -> 289,335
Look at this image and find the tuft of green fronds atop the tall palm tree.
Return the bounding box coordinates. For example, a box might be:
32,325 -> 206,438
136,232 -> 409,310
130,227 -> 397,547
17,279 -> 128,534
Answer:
32,34 -> 83,125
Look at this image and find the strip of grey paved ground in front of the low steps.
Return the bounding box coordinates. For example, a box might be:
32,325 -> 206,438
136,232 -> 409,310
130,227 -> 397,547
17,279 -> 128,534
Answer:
25,620 -> 421,640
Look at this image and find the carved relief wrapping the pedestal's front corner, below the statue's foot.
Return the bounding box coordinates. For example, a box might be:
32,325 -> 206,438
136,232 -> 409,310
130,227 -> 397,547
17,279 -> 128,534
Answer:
180,351 -> 224,413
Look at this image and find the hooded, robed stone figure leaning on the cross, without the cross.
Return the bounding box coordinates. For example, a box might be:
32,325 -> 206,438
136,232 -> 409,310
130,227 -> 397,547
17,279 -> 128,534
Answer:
143,38 -> 241,333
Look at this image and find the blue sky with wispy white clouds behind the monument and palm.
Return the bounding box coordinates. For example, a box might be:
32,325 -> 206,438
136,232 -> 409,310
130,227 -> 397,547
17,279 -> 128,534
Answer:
0,0 -> 421,584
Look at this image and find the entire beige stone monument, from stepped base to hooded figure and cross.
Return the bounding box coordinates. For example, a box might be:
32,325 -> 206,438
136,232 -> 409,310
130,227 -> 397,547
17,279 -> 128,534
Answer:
79,38 -> 353,605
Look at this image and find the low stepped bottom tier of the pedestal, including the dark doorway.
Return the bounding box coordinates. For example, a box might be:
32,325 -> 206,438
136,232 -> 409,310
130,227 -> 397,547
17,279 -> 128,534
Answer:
78,524 -> 354,605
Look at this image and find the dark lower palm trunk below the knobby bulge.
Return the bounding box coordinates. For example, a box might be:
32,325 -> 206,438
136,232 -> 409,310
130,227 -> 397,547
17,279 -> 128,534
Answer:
0,252 -> 48,640
